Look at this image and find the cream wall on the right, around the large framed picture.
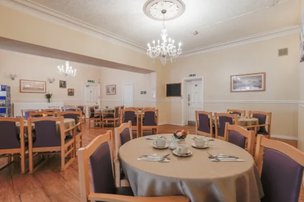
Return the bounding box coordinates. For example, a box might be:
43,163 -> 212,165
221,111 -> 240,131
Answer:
158,33 -> 299,139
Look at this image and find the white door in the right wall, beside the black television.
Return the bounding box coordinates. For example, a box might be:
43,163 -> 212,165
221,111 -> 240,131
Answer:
185,79 -> 203,125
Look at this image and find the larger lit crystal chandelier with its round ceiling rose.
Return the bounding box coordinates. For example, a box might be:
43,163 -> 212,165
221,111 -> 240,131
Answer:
144,0 -> 185,64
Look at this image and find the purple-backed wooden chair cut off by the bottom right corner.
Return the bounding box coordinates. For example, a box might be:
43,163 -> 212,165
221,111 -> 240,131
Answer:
255,135 -> 304,202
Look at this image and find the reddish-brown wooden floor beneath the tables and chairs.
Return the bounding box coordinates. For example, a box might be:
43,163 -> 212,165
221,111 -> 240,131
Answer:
0,122 -> 304,202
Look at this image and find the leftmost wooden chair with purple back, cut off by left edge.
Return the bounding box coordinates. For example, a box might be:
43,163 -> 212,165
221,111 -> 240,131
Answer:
0,117 -> 25,174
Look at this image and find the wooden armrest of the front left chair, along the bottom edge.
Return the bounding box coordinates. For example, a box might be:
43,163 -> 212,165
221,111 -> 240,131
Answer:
88,193 -> 190,202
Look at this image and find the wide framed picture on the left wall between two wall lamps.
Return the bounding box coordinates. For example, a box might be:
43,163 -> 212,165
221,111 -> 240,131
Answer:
20,79 -> 46,93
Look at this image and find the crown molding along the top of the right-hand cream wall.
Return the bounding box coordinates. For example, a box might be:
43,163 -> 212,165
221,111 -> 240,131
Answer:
182,25 -> 300,57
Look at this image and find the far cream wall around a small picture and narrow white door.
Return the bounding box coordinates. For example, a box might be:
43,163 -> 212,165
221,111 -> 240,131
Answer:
101,68 -> 156,108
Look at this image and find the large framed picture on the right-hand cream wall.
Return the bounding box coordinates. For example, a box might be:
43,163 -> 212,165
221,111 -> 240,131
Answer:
230,72 -> 266,92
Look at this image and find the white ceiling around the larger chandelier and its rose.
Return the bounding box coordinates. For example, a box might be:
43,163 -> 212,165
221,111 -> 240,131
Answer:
6,0 -> 300,53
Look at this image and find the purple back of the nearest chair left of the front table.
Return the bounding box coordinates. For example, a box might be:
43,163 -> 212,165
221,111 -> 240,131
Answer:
78,131 -> 115,201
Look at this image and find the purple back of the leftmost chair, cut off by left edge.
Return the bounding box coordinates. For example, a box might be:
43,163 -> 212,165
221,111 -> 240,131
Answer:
0,117 -> 24,150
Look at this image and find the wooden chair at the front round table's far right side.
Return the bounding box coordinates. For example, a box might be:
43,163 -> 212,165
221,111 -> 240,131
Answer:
225,123 -> 255,155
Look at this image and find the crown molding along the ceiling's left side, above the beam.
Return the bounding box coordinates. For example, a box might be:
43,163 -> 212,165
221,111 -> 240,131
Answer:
0,0 -> 145,53
